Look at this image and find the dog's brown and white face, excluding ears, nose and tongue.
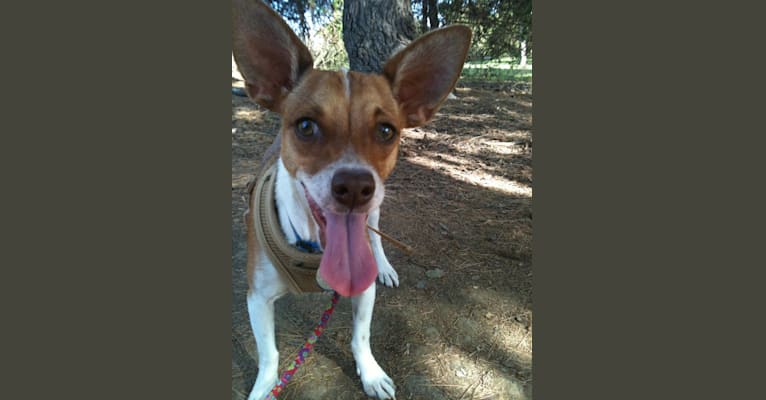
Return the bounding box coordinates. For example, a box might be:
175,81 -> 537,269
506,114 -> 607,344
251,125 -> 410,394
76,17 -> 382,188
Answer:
280,70 -> 405,217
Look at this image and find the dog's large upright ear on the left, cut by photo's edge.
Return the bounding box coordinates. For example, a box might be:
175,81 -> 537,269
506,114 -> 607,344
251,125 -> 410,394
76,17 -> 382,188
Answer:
231,0 -> 314,112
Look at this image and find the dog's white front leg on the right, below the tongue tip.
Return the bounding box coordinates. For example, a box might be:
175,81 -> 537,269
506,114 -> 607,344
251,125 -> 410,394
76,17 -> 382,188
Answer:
351,282 -> 395,399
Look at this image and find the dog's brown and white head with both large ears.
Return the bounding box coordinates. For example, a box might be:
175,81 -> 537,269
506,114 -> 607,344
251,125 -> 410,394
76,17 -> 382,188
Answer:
232,0 -> 471,294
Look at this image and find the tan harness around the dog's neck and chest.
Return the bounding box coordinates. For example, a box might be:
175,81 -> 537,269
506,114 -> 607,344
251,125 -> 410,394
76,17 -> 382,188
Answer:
250,163 -> 323,293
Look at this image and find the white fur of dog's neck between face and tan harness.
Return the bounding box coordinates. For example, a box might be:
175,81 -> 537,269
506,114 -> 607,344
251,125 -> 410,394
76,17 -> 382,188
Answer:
274,158 -> 321,247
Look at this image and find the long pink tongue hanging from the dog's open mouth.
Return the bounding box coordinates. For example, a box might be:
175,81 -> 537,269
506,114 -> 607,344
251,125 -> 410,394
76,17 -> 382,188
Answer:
319,212 -> 378,297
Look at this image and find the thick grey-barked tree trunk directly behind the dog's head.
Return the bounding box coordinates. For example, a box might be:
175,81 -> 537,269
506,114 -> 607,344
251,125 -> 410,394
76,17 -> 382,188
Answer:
343,0 -> 415,72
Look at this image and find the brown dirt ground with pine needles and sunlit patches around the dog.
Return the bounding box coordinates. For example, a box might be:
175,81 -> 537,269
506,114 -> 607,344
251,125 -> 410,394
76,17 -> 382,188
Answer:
231,82 -> 532,400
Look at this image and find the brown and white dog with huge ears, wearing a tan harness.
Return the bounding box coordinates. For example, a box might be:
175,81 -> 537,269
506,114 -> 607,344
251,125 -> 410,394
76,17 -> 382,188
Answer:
232,0 -> 471,400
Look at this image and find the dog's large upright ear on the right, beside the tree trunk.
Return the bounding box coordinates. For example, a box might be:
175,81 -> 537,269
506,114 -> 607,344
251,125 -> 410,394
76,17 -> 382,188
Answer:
383,25 -> 471,128
